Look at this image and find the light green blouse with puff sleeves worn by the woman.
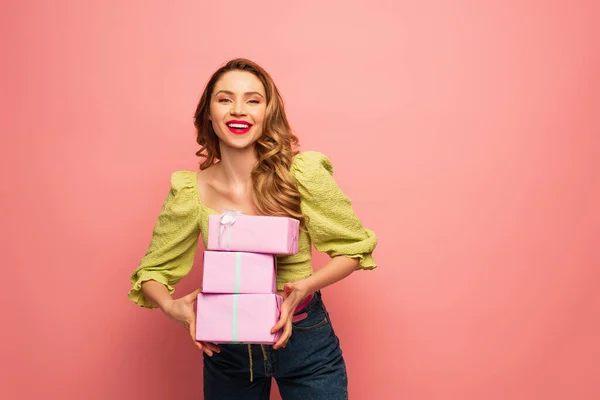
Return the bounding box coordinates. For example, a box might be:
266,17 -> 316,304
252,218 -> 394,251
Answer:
128,151 -> 377,308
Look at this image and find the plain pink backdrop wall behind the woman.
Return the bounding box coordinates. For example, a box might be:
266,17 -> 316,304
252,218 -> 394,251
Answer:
0,0 -> 600,400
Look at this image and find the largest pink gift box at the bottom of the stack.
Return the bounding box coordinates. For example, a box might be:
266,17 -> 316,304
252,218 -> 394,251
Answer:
196,293 -> 283,344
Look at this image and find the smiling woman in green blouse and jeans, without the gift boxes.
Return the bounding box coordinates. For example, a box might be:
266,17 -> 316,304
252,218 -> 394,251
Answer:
129,59 -> 377,400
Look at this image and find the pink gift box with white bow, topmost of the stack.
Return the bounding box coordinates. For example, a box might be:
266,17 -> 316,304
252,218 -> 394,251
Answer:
207,210 -> 300,254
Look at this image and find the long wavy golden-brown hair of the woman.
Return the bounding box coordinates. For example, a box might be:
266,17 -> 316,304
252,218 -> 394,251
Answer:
194,58 -> 306,226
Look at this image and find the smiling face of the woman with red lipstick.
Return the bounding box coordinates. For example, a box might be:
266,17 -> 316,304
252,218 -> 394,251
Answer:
209,71 -> 267,149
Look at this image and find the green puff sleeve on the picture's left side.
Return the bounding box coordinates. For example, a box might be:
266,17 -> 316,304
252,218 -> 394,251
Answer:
128,171 -> 200,308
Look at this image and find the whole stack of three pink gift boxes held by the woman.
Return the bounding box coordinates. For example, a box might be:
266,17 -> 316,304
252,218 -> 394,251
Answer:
196,210 -> 299,344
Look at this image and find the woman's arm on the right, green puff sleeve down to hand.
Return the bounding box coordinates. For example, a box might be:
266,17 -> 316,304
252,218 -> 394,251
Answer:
271,151 -> 377,349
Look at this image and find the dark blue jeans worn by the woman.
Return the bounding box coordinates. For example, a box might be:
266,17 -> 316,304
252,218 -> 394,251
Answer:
204,292 -> 348,400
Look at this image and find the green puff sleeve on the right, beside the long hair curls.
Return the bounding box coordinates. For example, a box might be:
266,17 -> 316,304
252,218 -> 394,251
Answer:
292,151 -> 377,269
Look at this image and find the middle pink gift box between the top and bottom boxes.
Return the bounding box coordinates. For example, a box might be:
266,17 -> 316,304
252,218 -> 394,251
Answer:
202,251 -> 276,294
